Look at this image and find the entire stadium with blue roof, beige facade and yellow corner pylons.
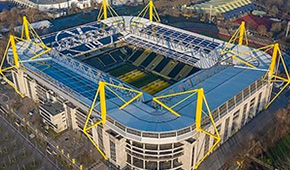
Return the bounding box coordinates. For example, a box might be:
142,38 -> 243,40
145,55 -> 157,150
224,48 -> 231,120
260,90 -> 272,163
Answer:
0,0 -> 290,170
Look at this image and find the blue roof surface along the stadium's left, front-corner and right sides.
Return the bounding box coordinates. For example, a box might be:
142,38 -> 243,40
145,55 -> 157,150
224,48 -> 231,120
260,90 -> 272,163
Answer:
25,56 -> 265,132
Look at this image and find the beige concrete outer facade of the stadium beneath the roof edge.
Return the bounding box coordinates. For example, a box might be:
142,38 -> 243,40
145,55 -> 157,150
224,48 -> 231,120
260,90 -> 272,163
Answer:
12,66 -> 272,170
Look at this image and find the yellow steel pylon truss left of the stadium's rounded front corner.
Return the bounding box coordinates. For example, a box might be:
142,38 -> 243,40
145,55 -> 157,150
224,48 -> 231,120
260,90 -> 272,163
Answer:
83,81 -> 143,159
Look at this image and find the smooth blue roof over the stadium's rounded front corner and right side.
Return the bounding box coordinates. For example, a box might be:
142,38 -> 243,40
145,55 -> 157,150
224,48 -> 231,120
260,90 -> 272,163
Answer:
108,66 -> 265,132
